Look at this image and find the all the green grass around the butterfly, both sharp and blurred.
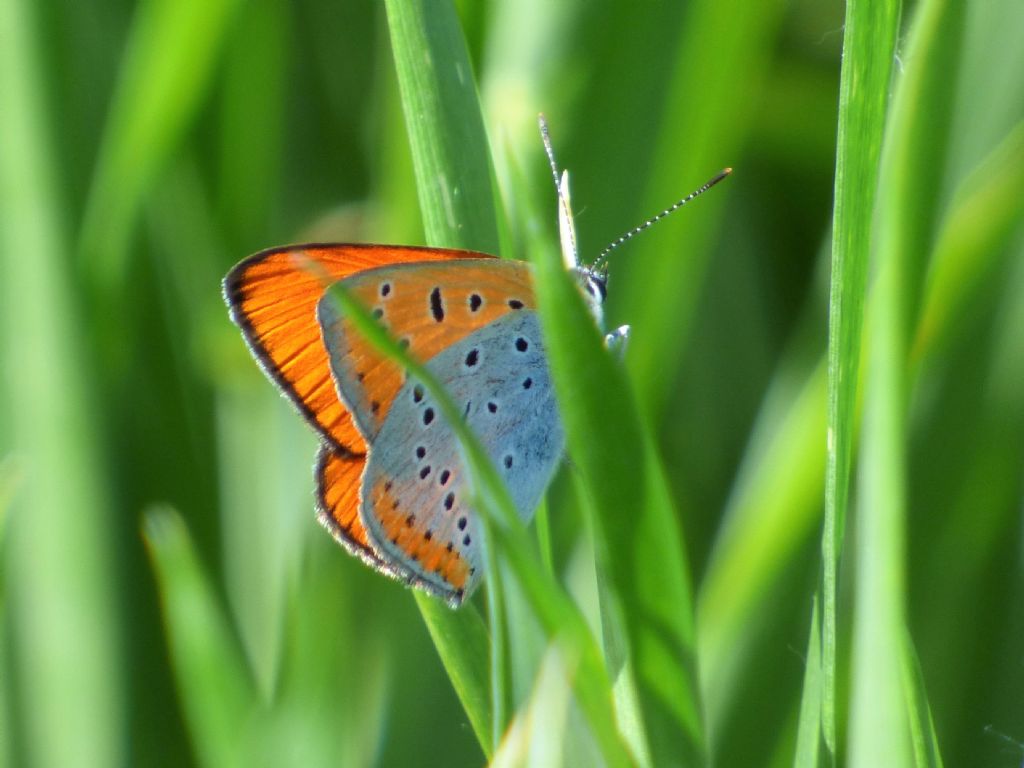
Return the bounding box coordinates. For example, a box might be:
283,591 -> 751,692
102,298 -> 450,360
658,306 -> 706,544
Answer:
0,0 -> 1024,768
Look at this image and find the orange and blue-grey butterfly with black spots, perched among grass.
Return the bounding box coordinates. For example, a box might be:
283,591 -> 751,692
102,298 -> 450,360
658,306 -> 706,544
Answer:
223,118 -> 718,607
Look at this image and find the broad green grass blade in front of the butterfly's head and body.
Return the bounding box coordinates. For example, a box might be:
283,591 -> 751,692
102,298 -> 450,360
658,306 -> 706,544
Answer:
530,210 -> 707,765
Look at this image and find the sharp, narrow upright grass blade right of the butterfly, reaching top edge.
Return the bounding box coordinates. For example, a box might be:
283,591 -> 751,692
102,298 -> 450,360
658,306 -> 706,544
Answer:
821,0 -> 900,756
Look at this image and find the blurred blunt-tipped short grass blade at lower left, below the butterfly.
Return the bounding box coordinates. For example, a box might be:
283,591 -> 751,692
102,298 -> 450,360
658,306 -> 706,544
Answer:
143,509 -> 258,768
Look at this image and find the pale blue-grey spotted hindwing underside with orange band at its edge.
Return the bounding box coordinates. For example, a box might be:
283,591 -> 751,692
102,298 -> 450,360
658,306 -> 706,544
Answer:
361,308 -> 564,604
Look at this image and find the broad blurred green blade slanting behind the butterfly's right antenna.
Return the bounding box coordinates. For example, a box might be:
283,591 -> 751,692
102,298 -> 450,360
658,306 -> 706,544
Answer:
611,0 -> 786,423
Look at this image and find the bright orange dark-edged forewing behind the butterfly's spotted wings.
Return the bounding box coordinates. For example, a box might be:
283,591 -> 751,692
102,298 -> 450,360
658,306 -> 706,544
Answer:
223,245 -> 494,454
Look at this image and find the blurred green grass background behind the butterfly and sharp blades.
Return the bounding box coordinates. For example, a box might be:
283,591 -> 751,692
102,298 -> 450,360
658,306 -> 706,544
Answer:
0,0 -> 1024,766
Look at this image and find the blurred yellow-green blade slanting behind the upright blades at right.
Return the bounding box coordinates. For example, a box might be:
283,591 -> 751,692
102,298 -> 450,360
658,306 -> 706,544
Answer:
697,117 -> 1024,722
